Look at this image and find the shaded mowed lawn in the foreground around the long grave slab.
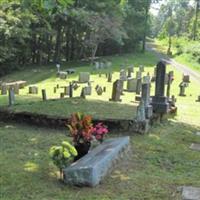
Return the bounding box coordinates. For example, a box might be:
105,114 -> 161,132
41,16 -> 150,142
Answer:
0,120 -> 200,200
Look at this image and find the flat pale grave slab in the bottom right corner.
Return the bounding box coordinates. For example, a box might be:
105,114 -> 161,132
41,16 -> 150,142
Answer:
182,186 -> 200,200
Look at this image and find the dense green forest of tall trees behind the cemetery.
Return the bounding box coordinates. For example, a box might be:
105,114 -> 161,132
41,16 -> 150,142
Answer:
0,0 -> 200,75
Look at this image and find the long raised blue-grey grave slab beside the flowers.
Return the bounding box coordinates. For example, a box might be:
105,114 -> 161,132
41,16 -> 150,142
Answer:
64,137 -> 129,187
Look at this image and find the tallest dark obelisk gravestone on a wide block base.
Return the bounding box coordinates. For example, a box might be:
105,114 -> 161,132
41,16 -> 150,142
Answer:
152,61 -> 169,114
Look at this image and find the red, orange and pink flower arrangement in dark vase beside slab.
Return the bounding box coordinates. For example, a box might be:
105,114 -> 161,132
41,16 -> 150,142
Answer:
67,113 -> 108,160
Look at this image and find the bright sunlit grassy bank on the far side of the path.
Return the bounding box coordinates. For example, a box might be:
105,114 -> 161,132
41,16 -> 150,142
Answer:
155,38 -> 200,72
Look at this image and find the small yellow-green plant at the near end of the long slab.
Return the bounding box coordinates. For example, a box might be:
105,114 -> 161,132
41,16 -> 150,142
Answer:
49,141 -> 77,179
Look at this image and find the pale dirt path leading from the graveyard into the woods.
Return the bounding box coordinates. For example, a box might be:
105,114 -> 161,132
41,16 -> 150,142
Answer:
147,44 -> 200,84
